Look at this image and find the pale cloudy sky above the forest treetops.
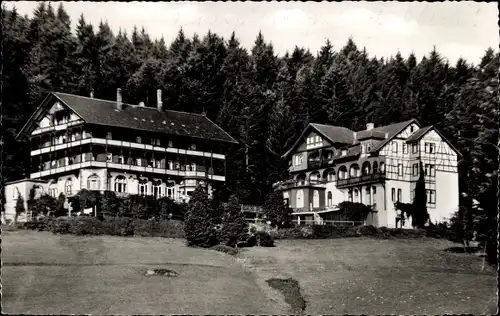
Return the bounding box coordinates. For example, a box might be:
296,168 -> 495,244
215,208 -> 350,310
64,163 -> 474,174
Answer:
4,1 -> 499,64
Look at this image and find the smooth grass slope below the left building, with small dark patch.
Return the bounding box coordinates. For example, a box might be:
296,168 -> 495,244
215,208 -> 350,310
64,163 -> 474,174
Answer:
2,231 -> 286,314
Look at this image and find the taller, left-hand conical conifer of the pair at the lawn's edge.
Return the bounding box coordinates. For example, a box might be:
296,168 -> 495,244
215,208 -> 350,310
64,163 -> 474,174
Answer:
184,185 -> 217,248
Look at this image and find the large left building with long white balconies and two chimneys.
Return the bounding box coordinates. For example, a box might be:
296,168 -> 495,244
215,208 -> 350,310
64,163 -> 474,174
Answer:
5,89 -> 237,220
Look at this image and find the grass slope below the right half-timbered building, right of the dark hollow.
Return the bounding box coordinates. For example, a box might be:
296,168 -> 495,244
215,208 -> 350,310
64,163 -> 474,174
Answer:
239,238 -> 497,315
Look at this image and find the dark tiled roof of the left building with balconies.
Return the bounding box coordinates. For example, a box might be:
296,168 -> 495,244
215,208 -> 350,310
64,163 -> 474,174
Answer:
53,92 -> 237,143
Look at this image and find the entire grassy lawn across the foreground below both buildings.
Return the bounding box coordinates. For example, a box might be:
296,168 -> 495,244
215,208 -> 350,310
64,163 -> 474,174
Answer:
2,231 -> 497,315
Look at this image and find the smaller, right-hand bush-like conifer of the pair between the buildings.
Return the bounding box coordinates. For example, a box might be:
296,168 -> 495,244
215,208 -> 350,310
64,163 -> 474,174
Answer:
221,196 -> 247,247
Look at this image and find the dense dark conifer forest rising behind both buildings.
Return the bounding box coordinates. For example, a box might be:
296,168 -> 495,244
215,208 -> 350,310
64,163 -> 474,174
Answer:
1,3 -> 499,256
